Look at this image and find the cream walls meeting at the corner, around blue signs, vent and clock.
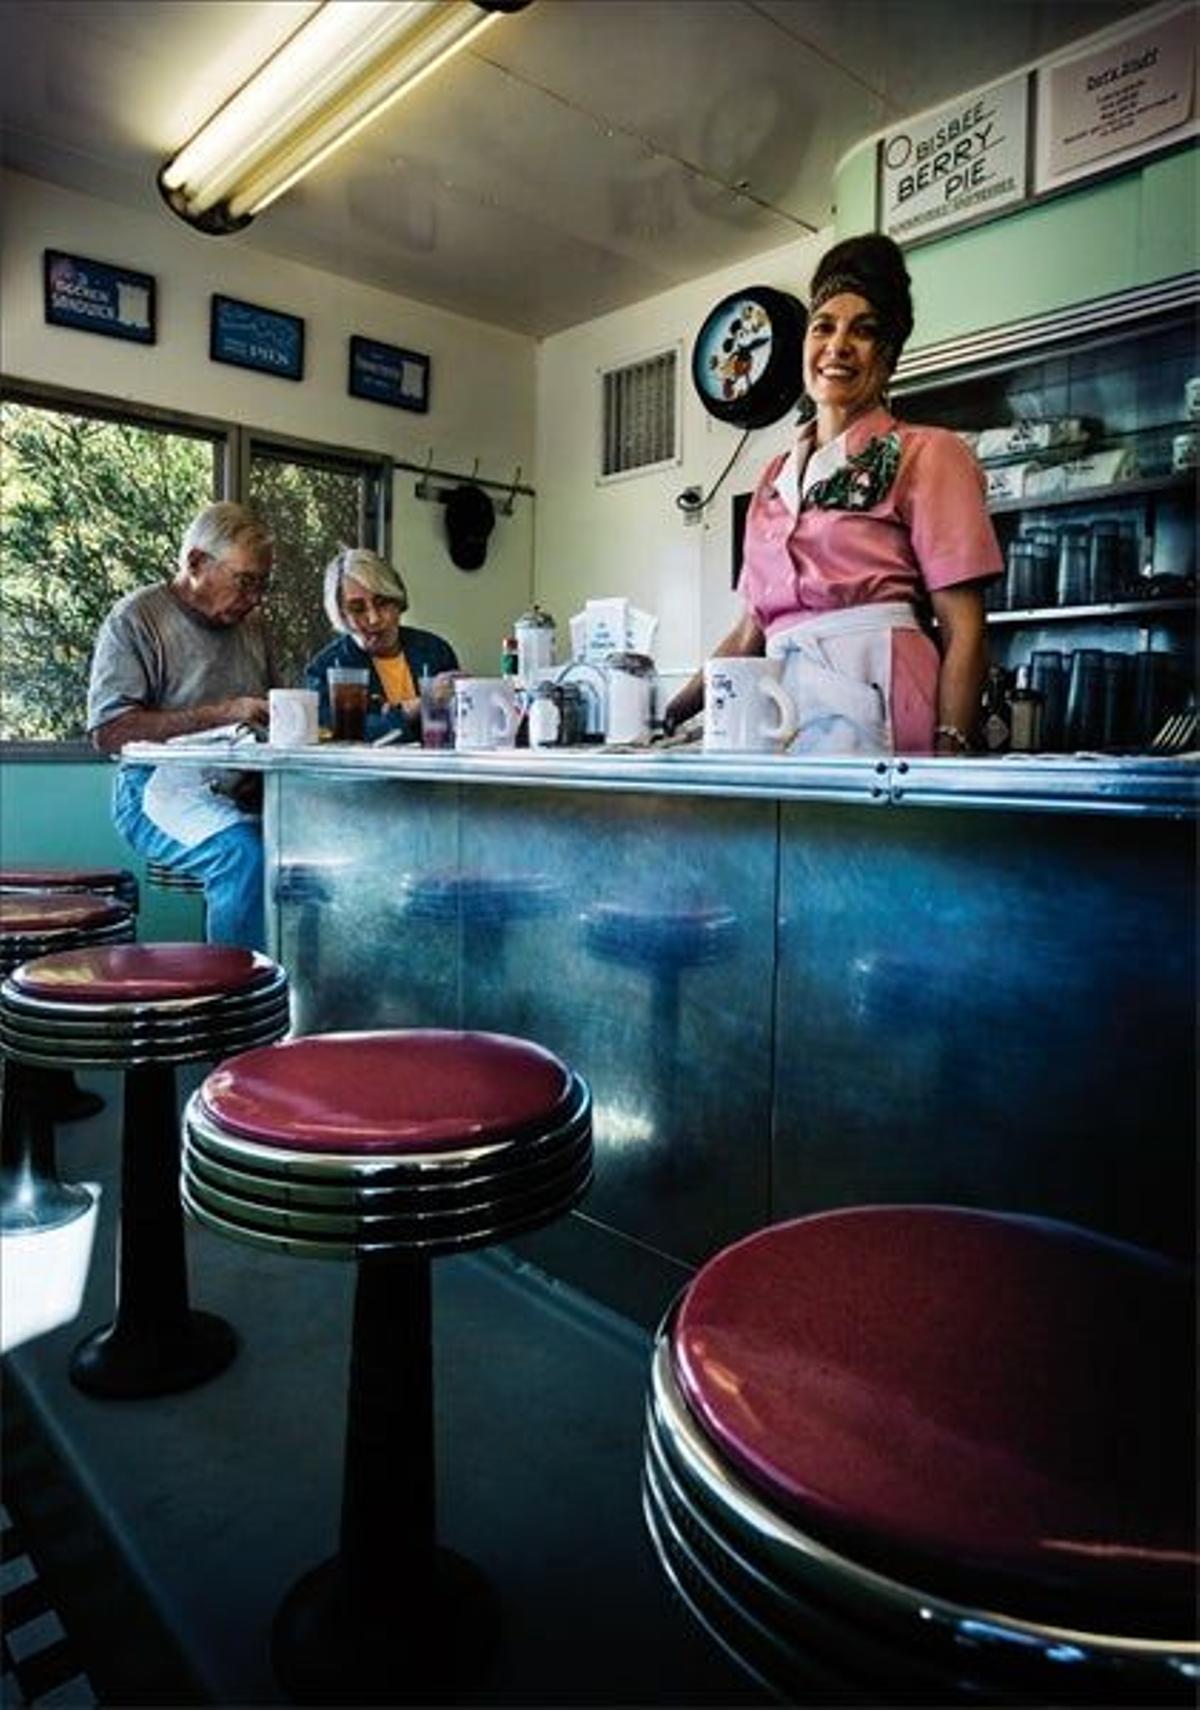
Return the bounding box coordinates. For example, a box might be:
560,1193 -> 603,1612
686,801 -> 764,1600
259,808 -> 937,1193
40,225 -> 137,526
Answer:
0,173 -> 831,687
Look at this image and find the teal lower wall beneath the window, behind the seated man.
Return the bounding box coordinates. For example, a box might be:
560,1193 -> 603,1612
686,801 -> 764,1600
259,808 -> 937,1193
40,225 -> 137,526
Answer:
0,759 -> 203,942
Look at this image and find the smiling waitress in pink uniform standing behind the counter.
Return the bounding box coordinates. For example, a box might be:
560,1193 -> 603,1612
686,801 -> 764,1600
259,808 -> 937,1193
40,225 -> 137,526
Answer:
663,233 -> 1003,754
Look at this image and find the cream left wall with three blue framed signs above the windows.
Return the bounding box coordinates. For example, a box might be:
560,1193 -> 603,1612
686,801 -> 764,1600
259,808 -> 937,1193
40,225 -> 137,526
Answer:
0,173 -> 535,672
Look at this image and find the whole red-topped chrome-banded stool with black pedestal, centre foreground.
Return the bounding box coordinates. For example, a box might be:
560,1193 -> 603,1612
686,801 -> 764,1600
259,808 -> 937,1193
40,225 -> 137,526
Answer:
183,1029 -> 591,1703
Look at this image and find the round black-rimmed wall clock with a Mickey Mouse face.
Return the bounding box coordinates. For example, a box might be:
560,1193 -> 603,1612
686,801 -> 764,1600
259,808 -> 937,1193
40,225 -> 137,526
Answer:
692,286 -> 807,428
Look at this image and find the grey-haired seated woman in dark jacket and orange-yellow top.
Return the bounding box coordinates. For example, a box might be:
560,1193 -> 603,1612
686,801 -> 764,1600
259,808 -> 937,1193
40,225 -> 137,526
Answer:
304,545 -> 458,742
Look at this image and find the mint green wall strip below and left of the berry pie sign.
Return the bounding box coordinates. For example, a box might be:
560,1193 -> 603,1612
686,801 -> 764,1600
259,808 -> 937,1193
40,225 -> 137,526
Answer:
836,144 -> 1200,349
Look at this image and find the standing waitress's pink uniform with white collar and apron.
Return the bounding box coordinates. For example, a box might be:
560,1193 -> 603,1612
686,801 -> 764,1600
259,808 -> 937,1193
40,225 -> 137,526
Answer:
738,407 -> 1003,754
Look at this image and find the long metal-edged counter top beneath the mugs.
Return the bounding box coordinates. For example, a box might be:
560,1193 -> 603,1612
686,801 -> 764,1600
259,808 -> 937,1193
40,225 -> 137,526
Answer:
121,740 -> 1200,817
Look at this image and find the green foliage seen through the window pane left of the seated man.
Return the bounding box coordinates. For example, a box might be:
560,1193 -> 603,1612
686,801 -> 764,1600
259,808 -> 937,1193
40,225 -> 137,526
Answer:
0,402 -> 217,742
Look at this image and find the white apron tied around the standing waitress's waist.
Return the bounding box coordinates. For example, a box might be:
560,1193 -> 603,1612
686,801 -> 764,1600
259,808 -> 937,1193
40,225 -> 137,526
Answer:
766,600 -> 921,754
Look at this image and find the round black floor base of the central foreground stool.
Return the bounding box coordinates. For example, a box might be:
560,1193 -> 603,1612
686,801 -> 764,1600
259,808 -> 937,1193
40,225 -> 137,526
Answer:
270,1549 -> 499,1705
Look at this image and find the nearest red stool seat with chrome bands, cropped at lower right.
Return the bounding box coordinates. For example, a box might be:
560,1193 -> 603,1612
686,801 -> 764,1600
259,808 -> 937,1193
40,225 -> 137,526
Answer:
643,1206 -> 1200,1705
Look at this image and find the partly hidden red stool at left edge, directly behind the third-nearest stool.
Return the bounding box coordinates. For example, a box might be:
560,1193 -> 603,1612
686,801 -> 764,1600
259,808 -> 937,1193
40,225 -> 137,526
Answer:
0,889 -> 133,1235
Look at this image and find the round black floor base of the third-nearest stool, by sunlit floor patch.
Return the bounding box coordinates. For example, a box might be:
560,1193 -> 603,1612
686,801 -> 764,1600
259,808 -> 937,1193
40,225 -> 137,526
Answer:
70,1312 -> 238,1400
